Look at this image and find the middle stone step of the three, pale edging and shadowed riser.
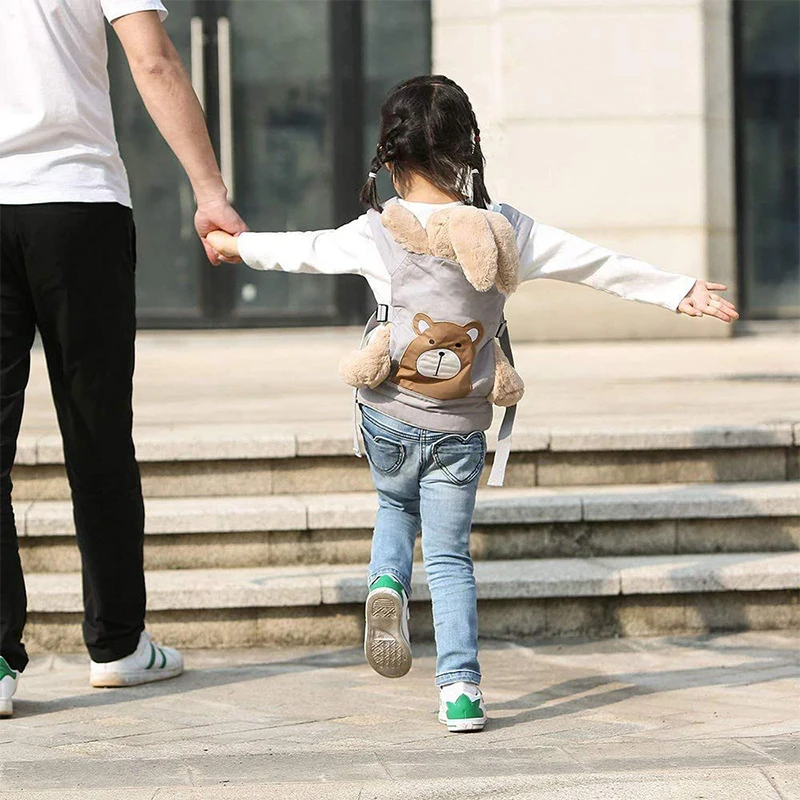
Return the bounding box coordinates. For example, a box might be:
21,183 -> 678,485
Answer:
16,481 -> 800,572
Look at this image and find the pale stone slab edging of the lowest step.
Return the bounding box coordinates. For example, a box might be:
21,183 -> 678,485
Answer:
20,553 -> 800,613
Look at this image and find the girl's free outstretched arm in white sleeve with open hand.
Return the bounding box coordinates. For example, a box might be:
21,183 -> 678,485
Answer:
520,222 -> 739,322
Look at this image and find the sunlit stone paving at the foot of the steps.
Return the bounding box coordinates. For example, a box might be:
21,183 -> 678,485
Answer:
0,633 -> 800,800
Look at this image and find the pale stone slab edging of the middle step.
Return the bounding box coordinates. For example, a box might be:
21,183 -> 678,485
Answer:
17,481 -> 800,536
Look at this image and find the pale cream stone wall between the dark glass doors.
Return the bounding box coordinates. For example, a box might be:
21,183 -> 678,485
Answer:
433,0 -> 736,340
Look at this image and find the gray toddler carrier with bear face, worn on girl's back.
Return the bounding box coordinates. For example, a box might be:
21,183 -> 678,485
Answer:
340,201 -> 533,486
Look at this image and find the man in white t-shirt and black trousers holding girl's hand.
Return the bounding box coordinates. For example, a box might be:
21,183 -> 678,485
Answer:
0,0 -> 245,716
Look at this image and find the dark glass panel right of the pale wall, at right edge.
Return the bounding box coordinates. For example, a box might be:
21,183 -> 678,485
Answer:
734,0 -> 800,319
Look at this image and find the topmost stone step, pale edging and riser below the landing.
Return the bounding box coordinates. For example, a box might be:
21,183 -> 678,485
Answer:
14,422 -> 800,500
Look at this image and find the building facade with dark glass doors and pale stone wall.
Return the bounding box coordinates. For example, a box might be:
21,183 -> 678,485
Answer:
110,0 -> 800,340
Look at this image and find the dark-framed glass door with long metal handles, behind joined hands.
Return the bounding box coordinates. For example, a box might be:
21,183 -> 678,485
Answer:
109,0 -> 430,327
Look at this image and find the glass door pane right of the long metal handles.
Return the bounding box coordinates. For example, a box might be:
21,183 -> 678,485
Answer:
228,0 -> 336,318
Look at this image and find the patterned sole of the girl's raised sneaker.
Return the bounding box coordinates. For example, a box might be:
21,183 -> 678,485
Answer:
364,591 -> 411,678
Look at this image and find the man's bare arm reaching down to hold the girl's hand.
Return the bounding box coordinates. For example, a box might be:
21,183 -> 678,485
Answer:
112,11 -> 247,264
